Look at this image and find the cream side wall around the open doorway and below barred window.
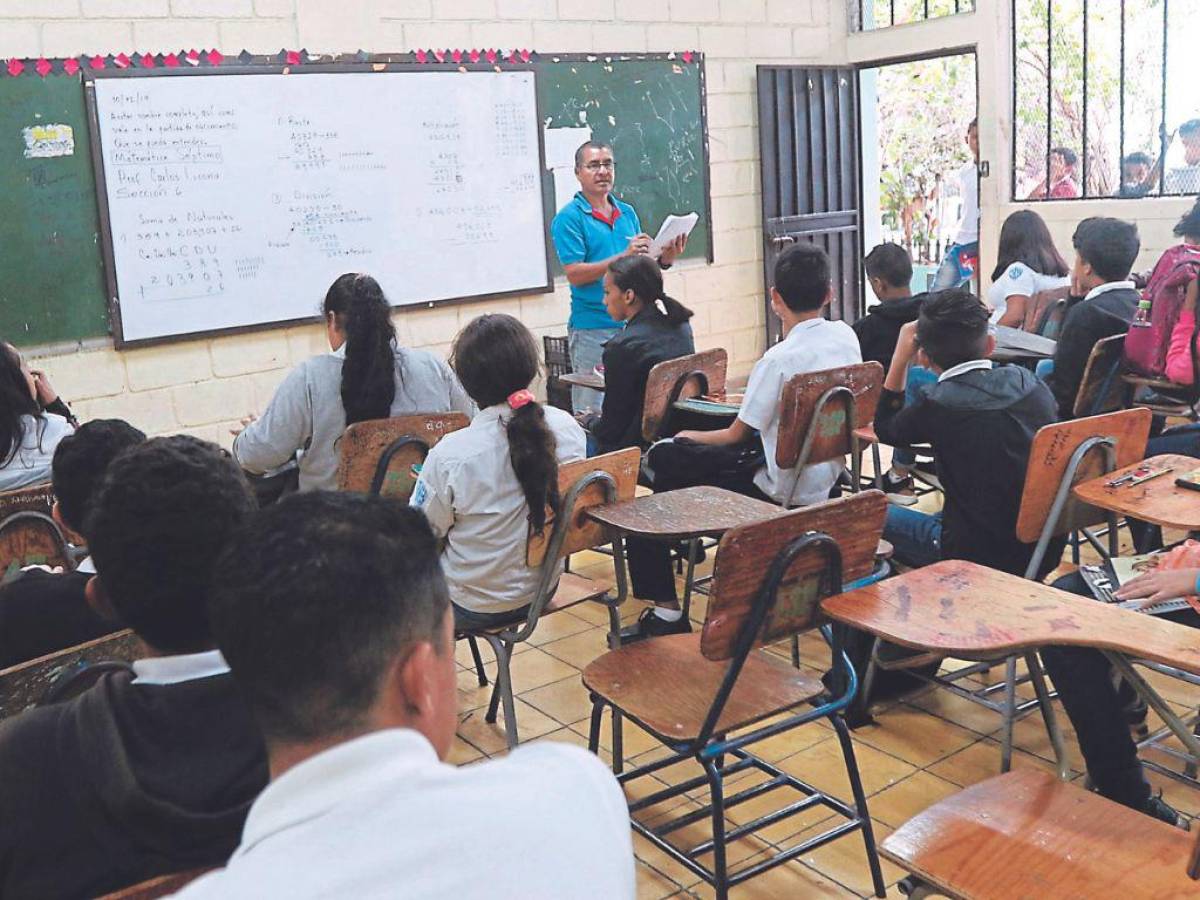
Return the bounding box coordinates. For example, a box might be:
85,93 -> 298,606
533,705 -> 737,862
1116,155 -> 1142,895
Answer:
846,0 -> 1195,286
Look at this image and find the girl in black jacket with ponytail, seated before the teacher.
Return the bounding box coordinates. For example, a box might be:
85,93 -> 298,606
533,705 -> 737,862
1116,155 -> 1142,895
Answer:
581,256 -> 696,454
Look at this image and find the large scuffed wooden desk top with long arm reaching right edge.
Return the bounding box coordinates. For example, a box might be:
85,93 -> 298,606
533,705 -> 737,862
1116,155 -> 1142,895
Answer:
821,564 -> 1200,674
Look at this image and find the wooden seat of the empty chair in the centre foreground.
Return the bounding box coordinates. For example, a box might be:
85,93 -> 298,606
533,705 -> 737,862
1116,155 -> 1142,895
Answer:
583,634 -> 824,743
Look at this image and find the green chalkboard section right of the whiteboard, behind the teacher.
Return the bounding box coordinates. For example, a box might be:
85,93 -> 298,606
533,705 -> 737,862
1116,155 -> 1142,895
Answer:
536,54 -> 712,259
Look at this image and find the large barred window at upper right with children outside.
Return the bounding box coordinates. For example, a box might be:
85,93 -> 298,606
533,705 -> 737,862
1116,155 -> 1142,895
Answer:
1013,0 -> 1200,200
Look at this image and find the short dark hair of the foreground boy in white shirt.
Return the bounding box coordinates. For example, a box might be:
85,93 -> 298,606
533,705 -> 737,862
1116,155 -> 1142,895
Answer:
210,491 -> 450,743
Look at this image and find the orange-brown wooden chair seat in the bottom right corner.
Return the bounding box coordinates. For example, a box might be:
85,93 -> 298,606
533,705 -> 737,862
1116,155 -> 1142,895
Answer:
880,769 -> 1200,900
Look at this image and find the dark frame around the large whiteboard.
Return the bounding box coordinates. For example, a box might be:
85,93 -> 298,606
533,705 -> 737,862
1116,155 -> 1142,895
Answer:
83,61 -> 554,350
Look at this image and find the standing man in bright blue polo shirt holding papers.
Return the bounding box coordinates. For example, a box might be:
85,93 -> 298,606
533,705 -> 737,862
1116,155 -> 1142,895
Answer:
550,140 -> 688,413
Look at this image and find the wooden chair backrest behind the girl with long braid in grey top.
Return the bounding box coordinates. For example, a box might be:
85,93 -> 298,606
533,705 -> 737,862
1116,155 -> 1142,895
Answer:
337,413 -> 469,500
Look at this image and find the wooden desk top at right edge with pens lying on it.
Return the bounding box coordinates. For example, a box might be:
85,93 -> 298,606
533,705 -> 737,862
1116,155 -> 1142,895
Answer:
1074,454 -> 1200,532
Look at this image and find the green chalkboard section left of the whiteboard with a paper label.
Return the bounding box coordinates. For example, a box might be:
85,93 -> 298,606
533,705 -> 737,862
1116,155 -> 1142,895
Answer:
0,74 -> 108,347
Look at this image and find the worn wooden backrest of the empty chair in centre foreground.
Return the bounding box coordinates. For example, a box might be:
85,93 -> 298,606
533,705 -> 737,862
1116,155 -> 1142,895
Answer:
700,491 -> 888,660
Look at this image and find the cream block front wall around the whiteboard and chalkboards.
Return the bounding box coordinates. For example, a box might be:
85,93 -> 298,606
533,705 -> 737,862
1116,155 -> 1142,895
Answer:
0,0 -> 846,444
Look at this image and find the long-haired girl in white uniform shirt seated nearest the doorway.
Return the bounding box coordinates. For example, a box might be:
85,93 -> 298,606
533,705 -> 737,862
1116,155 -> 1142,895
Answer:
988,210 -> 1070,328
